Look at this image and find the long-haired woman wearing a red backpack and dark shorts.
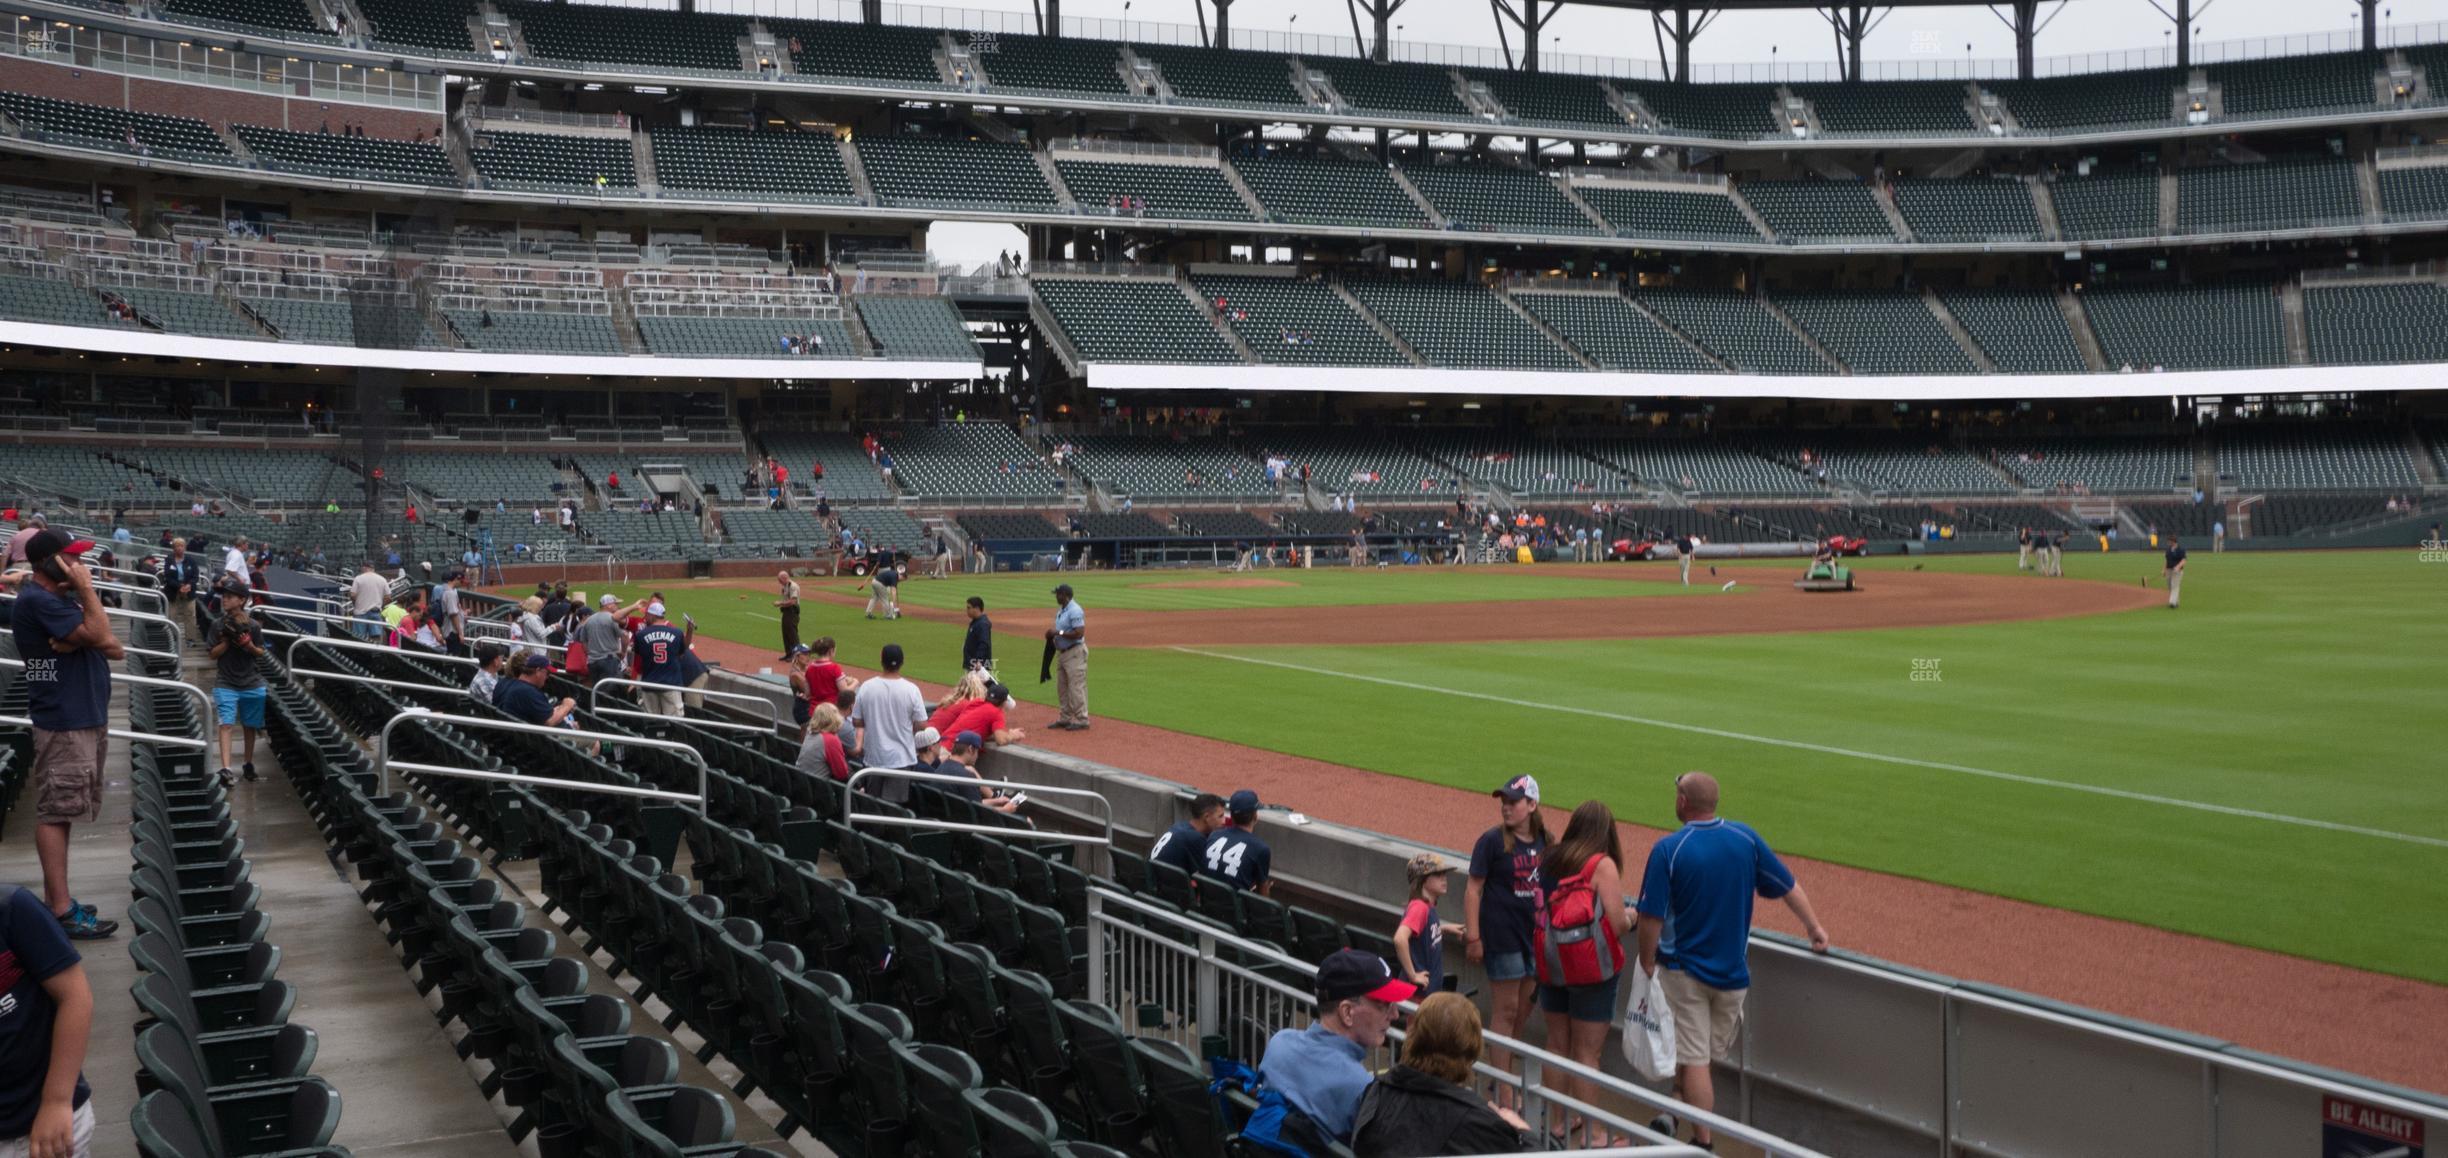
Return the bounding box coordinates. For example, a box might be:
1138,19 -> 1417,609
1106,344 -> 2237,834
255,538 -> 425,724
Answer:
1537,801 -> 1633,1146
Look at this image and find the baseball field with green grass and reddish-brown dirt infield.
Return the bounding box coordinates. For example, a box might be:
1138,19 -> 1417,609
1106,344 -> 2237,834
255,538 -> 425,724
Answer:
506,548 -> 2448,984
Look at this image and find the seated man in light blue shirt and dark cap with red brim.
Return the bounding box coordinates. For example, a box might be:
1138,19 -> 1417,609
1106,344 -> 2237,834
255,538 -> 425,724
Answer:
1258,950 -> 1420,1143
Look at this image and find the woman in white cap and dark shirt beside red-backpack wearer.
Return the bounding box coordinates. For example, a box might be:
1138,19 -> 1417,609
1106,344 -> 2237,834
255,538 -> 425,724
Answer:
1461,776 -> 1547,1104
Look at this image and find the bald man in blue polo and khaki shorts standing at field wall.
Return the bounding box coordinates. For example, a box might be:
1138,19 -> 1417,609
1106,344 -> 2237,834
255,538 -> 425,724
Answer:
1635,771 -> 1829,1146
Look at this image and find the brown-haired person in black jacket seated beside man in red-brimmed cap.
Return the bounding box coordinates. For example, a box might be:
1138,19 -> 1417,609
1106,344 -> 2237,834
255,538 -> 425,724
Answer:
1351,994 -> 1545,1158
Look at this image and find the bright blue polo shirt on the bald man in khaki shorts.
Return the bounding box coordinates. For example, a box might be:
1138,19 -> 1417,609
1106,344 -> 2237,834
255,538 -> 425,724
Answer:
1638,818 -> 1794,989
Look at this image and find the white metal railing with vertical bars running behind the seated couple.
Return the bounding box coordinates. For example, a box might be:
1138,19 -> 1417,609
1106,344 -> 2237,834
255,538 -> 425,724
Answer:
1087,886 -> 1819,1158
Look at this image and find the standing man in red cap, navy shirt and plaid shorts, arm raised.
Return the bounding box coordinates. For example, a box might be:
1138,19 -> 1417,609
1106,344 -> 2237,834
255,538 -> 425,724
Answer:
10,529 -> 127,940
